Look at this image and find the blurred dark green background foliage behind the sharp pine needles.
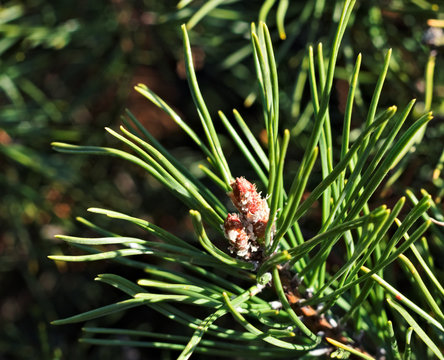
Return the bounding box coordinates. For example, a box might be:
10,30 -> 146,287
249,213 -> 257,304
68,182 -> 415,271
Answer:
0,0 -> 444,359
